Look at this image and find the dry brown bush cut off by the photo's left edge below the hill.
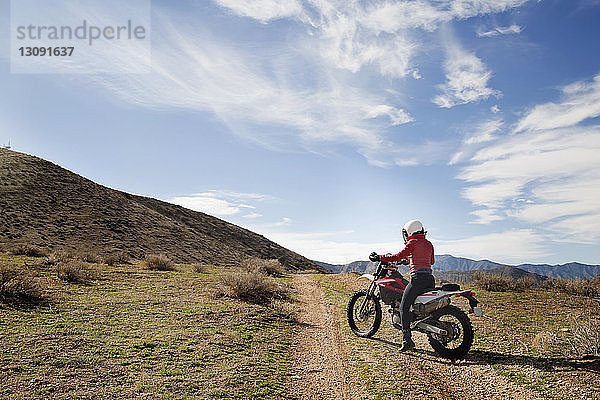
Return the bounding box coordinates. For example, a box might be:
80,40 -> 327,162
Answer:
0,266 -> 46,305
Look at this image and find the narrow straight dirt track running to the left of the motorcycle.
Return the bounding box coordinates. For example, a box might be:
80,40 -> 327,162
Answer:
291,275 -> 365,400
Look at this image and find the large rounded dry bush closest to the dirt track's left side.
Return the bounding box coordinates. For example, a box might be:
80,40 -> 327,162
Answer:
219,271 -> 291,304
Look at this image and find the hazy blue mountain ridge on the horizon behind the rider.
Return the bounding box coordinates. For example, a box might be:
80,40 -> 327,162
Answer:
316,254 -> 600,281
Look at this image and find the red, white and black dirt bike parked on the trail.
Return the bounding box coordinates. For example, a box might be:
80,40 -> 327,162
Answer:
347,262 -> 482,359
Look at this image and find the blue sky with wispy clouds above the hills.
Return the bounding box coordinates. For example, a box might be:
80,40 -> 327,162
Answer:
0,0 -> 600,264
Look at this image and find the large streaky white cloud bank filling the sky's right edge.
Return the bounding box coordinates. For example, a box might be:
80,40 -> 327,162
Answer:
458,77 -> 600,243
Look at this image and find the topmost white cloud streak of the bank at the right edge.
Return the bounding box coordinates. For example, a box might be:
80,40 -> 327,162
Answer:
516,74 -> 600,132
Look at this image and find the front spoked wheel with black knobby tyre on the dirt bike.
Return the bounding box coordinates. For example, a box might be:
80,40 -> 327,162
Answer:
347,290 -> 381,337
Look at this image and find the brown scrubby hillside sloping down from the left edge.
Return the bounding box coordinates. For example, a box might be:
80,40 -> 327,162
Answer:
0,149 -> 321,270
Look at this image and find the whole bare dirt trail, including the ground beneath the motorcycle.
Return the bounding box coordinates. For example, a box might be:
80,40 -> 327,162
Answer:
291,275 -> 542,399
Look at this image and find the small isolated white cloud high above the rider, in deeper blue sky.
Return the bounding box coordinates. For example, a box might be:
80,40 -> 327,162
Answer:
432,42 -> 500,108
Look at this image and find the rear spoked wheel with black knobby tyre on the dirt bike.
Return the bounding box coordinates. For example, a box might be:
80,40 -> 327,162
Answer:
427,306 -> 473,359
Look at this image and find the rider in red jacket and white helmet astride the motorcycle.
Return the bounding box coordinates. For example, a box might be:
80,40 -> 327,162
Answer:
369,220 -> 435,351
